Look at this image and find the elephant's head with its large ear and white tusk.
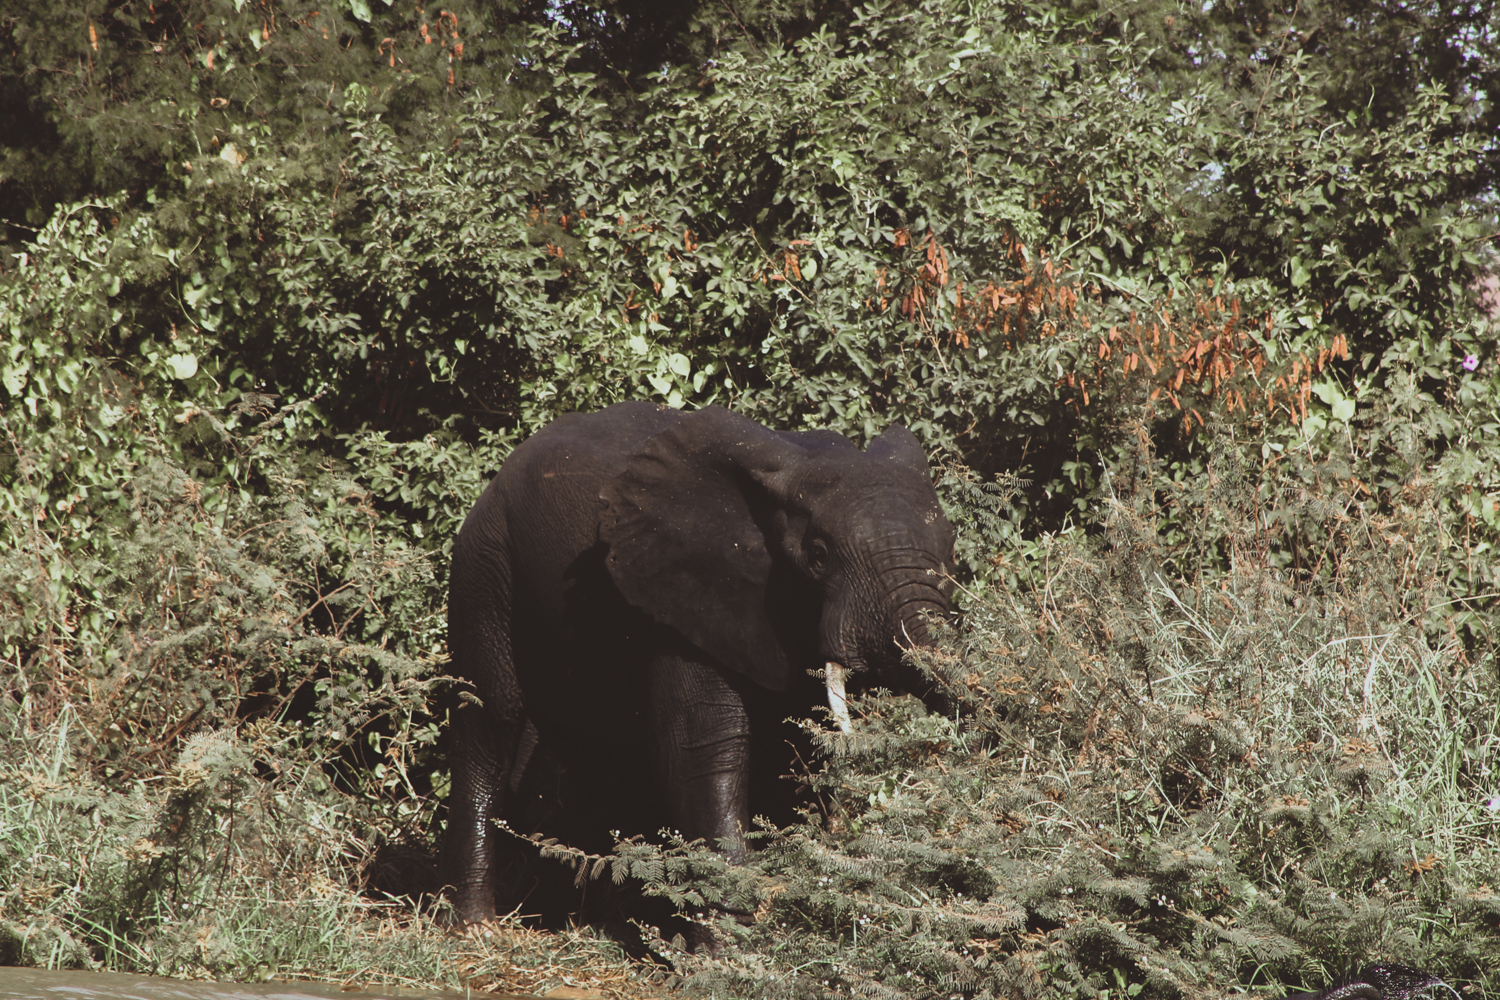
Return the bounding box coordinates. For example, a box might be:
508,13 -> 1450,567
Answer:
600,406 -> 953,726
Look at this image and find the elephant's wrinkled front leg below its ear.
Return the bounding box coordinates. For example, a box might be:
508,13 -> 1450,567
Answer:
650,655 -> 750,861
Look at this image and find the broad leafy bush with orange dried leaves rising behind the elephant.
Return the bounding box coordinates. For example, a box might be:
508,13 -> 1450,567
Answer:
6,3 -> 1497,592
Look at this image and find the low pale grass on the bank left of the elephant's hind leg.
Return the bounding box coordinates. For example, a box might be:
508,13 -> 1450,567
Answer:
0,709 -> 650,994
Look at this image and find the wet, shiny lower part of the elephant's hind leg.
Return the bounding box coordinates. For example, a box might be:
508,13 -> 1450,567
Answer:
438,703 -> 515,924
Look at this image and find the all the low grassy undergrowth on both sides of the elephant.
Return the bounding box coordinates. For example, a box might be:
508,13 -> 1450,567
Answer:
0,425 -> 1500,1000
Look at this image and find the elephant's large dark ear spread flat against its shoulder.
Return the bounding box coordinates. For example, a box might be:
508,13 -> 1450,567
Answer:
600,406 -> 806,691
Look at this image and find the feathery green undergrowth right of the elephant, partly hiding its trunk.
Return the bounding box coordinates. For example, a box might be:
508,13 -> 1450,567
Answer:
554,463 -> 1500,1000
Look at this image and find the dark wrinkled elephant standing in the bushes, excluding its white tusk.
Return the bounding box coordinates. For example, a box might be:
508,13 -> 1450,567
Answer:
441,403 -> 953,922
